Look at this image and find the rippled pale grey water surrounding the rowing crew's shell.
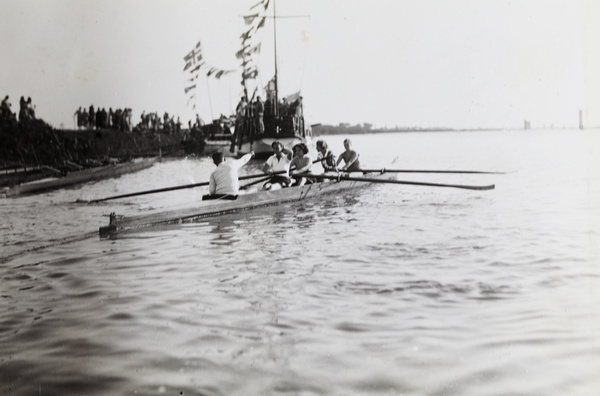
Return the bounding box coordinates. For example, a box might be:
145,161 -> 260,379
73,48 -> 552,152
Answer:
0,130 -> 600,396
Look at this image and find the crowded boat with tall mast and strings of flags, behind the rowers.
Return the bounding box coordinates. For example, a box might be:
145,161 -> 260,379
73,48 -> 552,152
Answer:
184,0 -> 312,157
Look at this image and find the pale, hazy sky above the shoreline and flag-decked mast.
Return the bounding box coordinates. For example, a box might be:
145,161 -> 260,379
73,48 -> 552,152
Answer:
0,0 -> 600,129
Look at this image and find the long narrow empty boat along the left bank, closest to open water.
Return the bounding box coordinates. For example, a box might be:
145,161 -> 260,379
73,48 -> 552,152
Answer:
0,158 -> 158,198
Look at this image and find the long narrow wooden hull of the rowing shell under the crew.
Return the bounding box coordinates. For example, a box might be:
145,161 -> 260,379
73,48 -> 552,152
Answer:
100,173 -> 396,237
